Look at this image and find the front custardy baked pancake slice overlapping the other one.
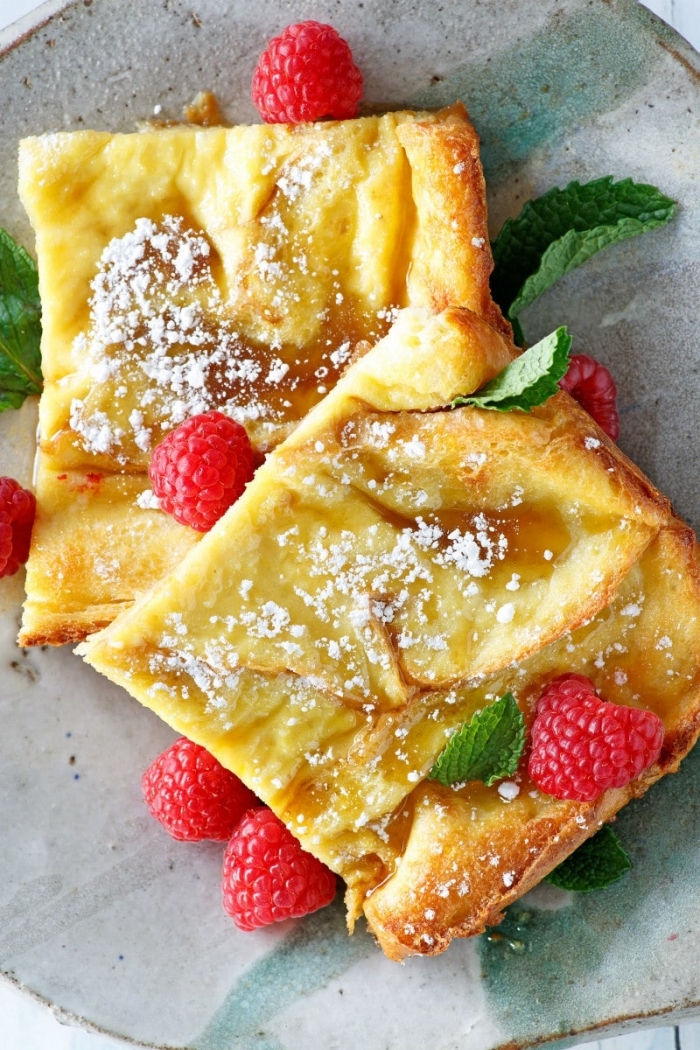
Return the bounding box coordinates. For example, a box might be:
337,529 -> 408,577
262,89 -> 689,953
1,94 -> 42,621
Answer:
79,308 -> 700,959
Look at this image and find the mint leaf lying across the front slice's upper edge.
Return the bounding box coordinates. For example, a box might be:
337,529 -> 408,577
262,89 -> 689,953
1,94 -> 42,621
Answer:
452,328 -> 571,412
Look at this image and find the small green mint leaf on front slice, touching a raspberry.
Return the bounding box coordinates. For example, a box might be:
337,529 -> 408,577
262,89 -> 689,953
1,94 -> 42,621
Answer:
428,693 -> 525,788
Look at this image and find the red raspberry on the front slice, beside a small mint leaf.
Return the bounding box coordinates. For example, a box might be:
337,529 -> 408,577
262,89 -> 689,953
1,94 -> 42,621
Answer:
528,674 -> 663,802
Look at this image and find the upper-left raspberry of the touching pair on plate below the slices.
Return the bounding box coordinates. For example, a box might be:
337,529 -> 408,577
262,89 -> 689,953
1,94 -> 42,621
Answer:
141,736 -> 259,842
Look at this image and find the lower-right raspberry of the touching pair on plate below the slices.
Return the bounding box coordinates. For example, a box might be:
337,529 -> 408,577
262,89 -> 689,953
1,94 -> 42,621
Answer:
222,807 -> 336,930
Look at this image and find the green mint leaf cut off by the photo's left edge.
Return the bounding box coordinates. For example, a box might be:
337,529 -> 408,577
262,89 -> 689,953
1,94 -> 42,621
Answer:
0,230 -> 42,412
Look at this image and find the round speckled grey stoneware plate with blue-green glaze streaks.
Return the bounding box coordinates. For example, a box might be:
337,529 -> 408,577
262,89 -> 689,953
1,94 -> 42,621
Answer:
0,0 -> 700,1050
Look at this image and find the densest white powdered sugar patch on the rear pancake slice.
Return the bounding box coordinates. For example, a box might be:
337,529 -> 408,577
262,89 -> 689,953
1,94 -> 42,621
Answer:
70,215 -> 288,462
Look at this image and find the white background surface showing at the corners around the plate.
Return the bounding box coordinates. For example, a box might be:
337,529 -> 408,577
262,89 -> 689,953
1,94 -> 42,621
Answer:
0,0 -> 700,1050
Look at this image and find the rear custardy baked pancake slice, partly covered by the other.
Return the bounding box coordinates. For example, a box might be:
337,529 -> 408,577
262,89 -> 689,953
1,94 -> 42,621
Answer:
19,105 -> 509,646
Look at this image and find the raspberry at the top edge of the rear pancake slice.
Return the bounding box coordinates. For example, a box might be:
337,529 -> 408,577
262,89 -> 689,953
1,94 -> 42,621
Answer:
253,21 -> 362,124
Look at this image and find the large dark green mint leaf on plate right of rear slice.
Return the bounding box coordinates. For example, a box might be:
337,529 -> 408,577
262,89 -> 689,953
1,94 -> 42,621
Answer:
491,175 -> 676,318
